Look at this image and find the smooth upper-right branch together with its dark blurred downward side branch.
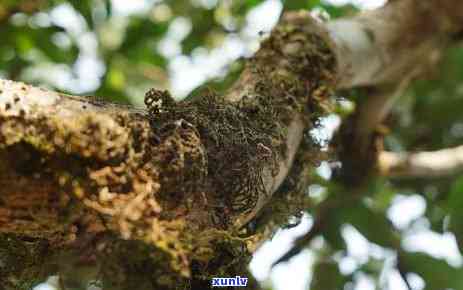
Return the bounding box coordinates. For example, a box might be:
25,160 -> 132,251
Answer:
276,0 -> 463,264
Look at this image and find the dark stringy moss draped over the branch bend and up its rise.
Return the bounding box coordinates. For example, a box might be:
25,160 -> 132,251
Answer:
146,14 -> 336,231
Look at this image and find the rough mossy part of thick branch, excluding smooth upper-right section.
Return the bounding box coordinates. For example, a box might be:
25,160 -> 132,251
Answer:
0,13 -> 335,289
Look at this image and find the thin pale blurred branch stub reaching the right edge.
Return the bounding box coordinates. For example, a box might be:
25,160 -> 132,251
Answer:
378,146 -> 463,178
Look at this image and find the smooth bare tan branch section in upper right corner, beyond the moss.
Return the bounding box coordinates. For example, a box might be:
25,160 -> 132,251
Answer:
326,0 -> 463,88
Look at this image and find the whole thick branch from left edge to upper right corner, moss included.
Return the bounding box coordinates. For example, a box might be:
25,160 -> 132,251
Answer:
0,0 -> 463,289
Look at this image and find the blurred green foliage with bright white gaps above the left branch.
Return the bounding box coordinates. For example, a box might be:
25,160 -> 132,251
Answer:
0,0 -> 356,103
